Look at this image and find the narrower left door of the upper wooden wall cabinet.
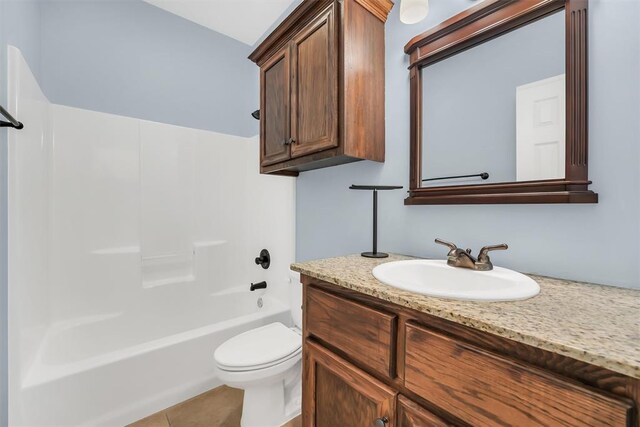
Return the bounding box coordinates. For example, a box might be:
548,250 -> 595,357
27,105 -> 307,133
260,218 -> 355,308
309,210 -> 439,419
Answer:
260,47 -> 291,166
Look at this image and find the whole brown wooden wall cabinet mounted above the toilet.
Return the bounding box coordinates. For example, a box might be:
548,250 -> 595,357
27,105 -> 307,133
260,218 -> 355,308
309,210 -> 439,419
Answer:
249,0 -> 393,175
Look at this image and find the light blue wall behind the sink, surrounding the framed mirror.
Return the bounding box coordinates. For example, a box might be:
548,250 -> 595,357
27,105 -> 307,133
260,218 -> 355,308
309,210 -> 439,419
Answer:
296,0 -> 640,288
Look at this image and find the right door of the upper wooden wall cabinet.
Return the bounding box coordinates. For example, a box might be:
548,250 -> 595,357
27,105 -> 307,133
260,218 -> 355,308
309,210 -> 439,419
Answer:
291,5 -> 338,157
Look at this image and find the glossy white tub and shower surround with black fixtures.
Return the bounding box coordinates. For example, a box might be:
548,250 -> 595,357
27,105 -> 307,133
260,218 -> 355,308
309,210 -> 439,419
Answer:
8,48 -> 295,425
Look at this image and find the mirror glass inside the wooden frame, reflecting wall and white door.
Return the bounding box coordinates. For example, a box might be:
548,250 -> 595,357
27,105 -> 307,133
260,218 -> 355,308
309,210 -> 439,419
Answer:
420,12 -> 566,187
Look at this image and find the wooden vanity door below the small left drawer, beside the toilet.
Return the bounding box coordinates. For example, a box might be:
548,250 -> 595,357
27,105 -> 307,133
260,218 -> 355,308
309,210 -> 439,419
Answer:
302,340 -> 396,427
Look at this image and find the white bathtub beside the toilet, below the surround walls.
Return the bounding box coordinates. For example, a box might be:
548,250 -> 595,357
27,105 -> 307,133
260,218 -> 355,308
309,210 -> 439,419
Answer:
15,288 -> 291,427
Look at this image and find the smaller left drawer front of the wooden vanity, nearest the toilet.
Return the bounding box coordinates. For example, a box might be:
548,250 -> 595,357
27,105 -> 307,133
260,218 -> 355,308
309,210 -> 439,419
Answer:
304,286 -> 396,377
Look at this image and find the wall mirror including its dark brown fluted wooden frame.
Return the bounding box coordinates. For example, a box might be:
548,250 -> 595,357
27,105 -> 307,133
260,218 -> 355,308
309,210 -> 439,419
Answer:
405,0 -> 597,204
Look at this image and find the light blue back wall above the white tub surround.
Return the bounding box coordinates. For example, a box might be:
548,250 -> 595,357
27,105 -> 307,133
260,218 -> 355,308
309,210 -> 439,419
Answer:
41,0 -> 259,136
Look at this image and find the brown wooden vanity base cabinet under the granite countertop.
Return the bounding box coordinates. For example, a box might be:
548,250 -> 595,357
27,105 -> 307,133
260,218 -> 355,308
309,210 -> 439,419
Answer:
302,275 -> 640,427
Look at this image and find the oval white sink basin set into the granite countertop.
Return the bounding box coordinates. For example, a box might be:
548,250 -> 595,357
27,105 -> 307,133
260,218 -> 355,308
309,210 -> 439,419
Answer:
373,260 -> 540,301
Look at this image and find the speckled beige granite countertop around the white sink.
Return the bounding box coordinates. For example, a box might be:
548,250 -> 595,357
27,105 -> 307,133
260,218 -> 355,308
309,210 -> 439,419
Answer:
291,255 -> 640,379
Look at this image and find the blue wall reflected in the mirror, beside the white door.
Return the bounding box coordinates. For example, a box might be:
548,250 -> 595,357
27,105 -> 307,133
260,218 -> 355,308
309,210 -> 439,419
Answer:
421,12 -> 565,186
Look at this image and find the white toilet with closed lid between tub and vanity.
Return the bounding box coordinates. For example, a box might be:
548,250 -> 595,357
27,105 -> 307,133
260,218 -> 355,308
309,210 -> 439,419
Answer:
214,272 -> 302,427
